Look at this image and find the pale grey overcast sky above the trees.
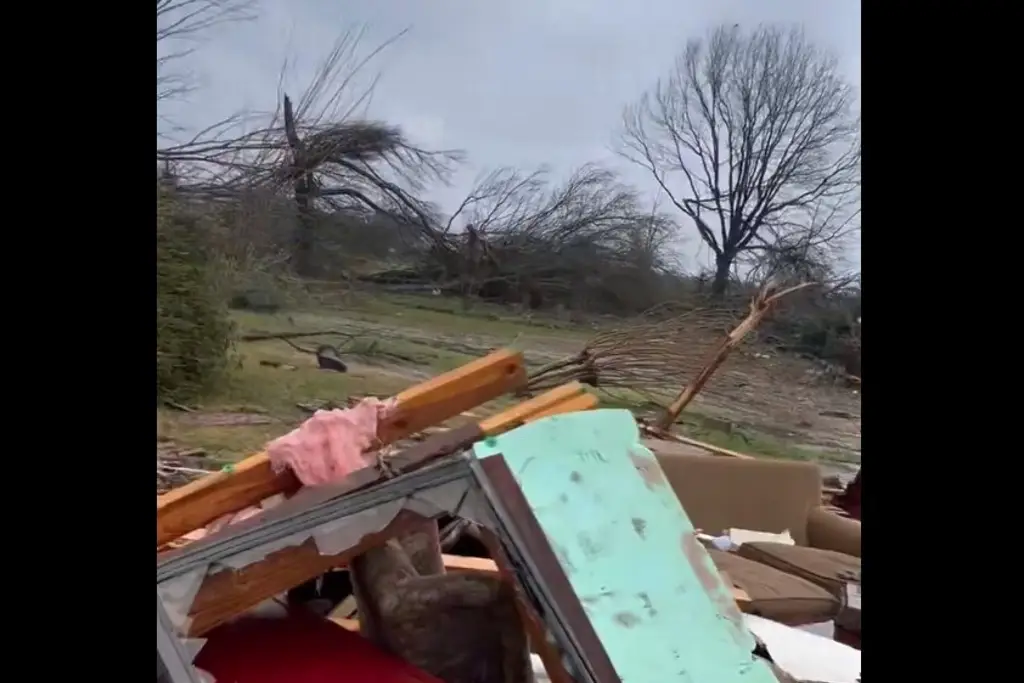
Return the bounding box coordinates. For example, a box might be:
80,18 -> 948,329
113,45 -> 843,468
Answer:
161,0 -> 860,272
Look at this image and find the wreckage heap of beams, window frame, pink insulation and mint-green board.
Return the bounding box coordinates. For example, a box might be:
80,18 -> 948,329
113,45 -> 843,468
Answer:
157,350 -> 859,683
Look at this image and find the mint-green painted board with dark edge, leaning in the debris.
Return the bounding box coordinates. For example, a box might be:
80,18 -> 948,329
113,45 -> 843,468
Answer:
475,410 -> 775,683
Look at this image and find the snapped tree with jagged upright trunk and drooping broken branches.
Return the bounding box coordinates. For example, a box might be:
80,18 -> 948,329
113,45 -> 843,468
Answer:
157,30 -> 460,276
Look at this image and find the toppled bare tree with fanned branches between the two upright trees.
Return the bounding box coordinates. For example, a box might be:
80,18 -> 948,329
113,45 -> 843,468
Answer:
411,165 -> 674,308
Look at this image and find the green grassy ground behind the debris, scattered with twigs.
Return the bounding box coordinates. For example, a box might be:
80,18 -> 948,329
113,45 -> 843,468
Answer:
157,296 -> 856,461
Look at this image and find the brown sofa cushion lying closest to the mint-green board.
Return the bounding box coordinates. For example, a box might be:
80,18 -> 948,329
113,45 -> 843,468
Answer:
708,549 -> 840,625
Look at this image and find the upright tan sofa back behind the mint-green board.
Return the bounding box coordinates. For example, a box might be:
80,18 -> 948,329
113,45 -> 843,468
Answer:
643,439 -> 821,546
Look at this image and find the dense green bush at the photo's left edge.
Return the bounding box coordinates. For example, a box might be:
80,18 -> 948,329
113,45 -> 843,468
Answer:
157,189 -> 233,400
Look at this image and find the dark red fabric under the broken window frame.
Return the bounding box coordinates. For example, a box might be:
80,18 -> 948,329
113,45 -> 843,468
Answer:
195,611 -> 442,683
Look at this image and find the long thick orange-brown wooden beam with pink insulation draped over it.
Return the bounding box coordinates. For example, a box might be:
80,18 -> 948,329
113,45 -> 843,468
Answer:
157,349 -> 526,548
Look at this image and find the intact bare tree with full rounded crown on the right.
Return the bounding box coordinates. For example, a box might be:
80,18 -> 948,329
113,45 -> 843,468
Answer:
622,27 -> 860,296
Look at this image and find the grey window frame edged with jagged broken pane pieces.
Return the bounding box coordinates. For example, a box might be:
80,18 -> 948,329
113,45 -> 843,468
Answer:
157,454 -> 620,683
